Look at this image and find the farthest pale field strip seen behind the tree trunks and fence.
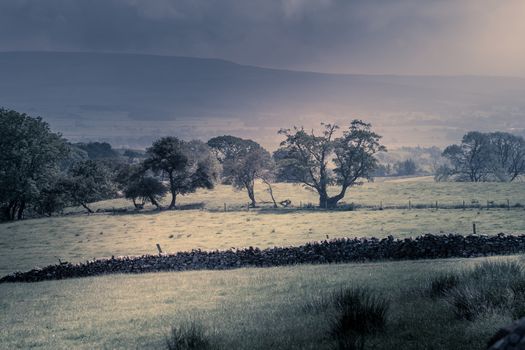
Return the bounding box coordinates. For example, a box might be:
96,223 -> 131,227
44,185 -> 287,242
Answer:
70,176 -> 525,210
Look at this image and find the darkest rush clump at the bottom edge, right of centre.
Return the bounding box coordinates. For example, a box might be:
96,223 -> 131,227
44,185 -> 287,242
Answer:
330,288 -> 389,350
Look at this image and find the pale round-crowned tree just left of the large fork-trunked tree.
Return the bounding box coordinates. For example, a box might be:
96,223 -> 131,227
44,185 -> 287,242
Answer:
208,135 -> 275,207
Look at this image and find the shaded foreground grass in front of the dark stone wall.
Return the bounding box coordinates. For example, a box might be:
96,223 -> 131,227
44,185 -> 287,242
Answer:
0,257 -> 519,350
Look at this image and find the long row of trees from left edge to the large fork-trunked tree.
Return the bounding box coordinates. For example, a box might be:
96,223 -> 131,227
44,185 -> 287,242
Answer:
0,109 -> 386,220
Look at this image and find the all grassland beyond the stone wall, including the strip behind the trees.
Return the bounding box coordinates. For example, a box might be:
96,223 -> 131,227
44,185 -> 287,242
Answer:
0,178 -> 525,275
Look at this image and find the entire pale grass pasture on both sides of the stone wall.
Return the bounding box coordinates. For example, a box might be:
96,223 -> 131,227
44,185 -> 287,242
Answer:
0,178 -> 525,350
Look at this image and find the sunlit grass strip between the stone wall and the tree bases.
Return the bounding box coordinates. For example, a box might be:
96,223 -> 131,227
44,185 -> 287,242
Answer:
0,209 -> 525,275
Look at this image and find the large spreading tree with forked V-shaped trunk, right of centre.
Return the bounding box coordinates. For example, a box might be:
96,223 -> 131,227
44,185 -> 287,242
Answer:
279,120 -> 386,208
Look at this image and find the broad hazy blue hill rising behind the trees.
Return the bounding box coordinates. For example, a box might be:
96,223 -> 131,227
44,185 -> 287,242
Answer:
0,52 -> 525,148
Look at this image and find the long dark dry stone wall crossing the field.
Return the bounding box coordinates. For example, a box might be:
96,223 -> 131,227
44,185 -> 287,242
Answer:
0,234 -> 525,283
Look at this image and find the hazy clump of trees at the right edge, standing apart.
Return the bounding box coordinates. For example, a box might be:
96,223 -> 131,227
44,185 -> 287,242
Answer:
436,131 -> 525,182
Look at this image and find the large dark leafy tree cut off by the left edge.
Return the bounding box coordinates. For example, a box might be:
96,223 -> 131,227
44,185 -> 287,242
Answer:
0,109 -> 68,220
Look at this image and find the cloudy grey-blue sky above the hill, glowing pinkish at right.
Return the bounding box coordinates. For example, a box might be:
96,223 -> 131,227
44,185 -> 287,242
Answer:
0,0 -> 525,77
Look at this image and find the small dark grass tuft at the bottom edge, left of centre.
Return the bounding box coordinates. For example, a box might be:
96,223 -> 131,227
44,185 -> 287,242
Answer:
166,322 -> 212,350
